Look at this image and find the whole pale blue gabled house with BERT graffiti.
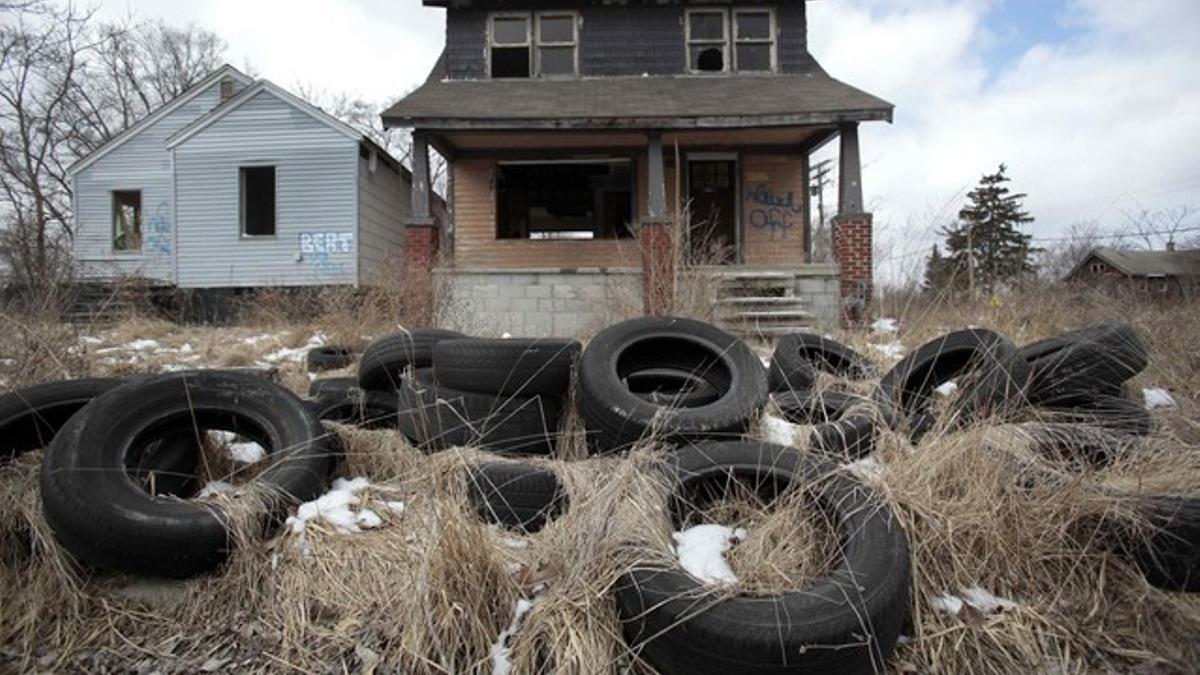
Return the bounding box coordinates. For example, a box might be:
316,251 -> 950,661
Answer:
68,66 -> 412,288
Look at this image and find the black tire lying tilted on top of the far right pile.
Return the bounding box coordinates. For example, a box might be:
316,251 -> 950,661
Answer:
1020,323 -> 1150,405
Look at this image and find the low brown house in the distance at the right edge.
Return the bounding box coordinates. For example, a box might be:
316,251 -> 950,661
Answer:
1064,245 -> 1200,298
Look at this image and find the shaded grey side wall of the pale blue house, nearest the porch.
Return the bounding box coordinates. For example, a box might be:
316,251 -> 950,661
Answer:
358,152 -> 412,283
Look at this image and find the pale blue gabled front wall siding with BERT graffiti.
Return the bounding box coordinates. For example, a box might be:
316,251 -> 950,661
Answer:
175,91 -> 359,288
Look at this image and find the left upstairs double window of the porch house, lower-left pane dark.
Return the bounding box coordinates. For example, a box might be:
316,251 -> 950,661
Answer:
488,12 -> 580,78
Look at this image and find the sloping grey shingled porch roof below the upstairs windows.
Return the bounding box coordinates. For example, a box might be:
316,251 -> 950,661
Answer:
383,55 -> 893,130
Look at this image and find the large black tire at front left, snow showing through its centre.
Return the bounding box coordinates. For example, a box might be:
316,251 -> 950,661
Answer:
41,371 -> 334,577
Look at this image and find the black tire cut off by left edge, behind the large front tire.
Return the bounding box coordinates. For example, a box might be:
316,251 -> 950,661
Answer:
0,378 -> 121,460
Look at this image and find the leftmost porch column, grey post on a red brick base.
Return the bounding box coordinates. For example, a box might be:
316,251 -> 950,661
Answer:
400,131 -> 439,325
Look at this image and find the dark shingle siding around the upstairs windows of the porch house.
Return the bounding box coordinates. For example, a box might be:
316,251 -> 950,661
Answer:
445,0 -> 814,79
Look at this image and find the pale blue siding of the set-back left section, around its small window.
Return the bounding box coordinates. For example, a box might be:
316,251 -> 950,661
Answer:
74,82 -> 241,281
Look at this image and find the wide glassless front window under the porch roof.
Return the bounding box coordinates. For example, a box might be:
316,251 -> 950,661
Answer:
496,160 -> 634,239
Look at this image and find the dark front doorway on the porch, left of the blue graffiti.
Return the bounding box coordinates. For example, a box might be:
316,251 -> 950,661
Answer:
688,160 -> 738,264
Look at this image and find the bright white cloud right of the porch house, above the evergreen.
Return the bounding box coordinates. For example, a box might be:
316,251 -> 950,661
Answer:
809,0 -> 1200,279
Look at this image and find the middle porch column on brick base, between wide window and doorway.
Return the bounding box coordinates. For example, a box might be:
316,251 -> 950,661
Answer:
637,131 -> 674,316
